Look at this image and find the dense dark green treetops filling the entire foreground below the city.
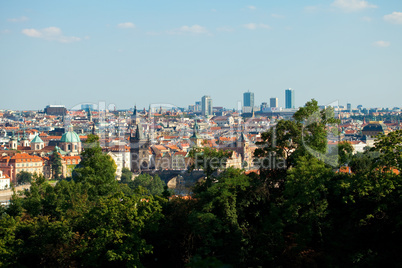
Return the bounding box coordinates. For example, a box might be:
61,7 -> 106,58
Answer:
0,105 -> 402,267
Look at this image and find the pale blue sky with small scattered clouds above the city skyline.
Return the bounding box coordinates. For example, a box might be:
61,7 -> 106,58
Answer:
0,0 -> 402,110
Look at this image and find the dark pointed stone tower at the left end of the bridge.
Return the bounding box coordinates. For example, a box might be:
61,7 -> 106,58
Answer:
130,124 -> 149,173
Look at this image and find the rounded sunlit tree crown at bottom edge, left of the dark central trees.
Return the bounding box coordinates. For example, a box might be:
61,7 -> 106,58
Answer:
76,193 -> 161,267
